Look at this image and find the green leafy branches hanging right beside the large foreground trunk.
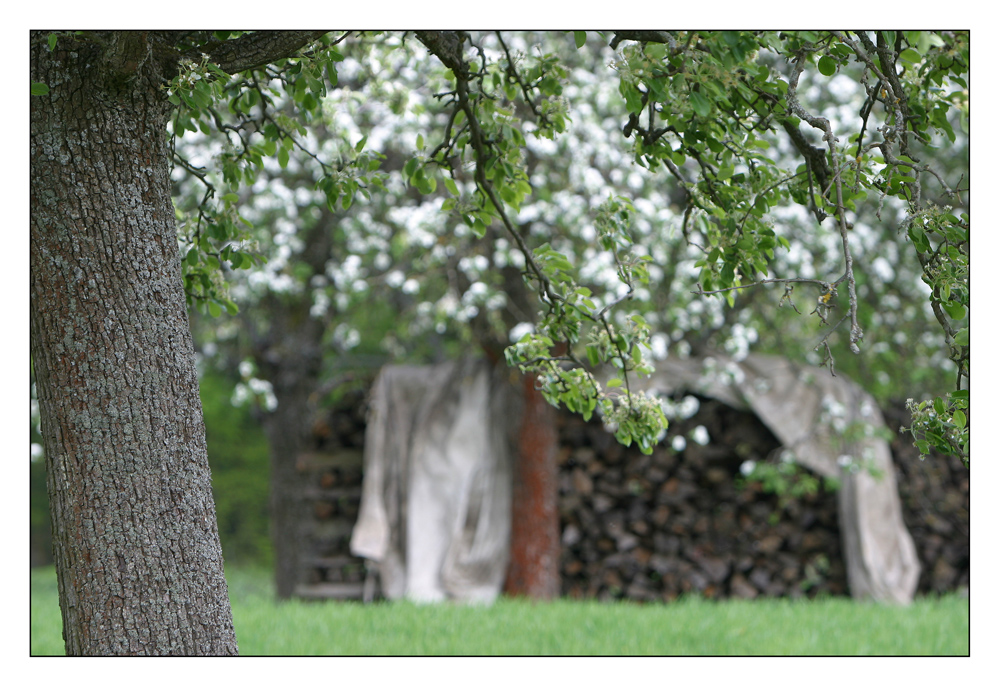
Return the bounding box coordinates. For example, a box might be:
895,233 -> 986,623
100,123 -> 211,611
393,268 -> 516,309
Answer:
164,32 -> 383,315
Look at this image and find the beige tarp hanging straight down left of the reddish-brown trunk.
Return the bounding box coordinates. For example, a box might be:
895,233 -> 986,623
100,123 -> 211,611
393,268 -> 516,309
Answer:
351,359 -> 512,601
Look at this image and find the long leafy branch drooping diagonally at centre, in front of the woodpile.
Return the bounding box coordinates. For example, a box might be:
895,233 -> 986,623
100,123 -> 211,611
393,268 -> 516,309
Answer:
418,31 -> 666,453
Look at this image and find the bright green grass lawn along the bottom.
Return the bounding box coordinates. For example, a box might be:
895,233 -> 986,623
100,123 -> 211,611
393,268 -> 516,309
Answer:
31,568 -> 969,656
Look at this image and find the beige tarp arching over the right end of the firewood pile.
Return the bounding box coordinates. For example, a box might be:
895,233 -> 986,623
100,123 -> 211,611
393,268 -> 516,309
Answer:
632,355 -> 920,604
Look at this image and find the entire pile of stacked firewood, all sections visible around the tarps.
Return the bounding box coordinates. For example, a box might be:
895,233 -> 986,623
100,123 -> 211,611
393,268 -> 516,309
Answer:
300,382 -> 969,601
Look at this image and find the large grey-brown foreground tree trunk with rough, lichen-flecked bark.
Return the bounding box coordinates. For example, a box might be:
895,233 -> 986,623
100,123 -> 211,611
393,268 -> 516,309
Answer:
31,32 -> 237,655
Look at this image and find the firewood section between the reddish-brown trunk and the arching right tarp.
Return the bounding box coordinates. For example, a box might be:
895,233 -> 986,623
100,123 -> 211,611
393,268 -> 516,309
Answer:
559,399 -> 847,601
